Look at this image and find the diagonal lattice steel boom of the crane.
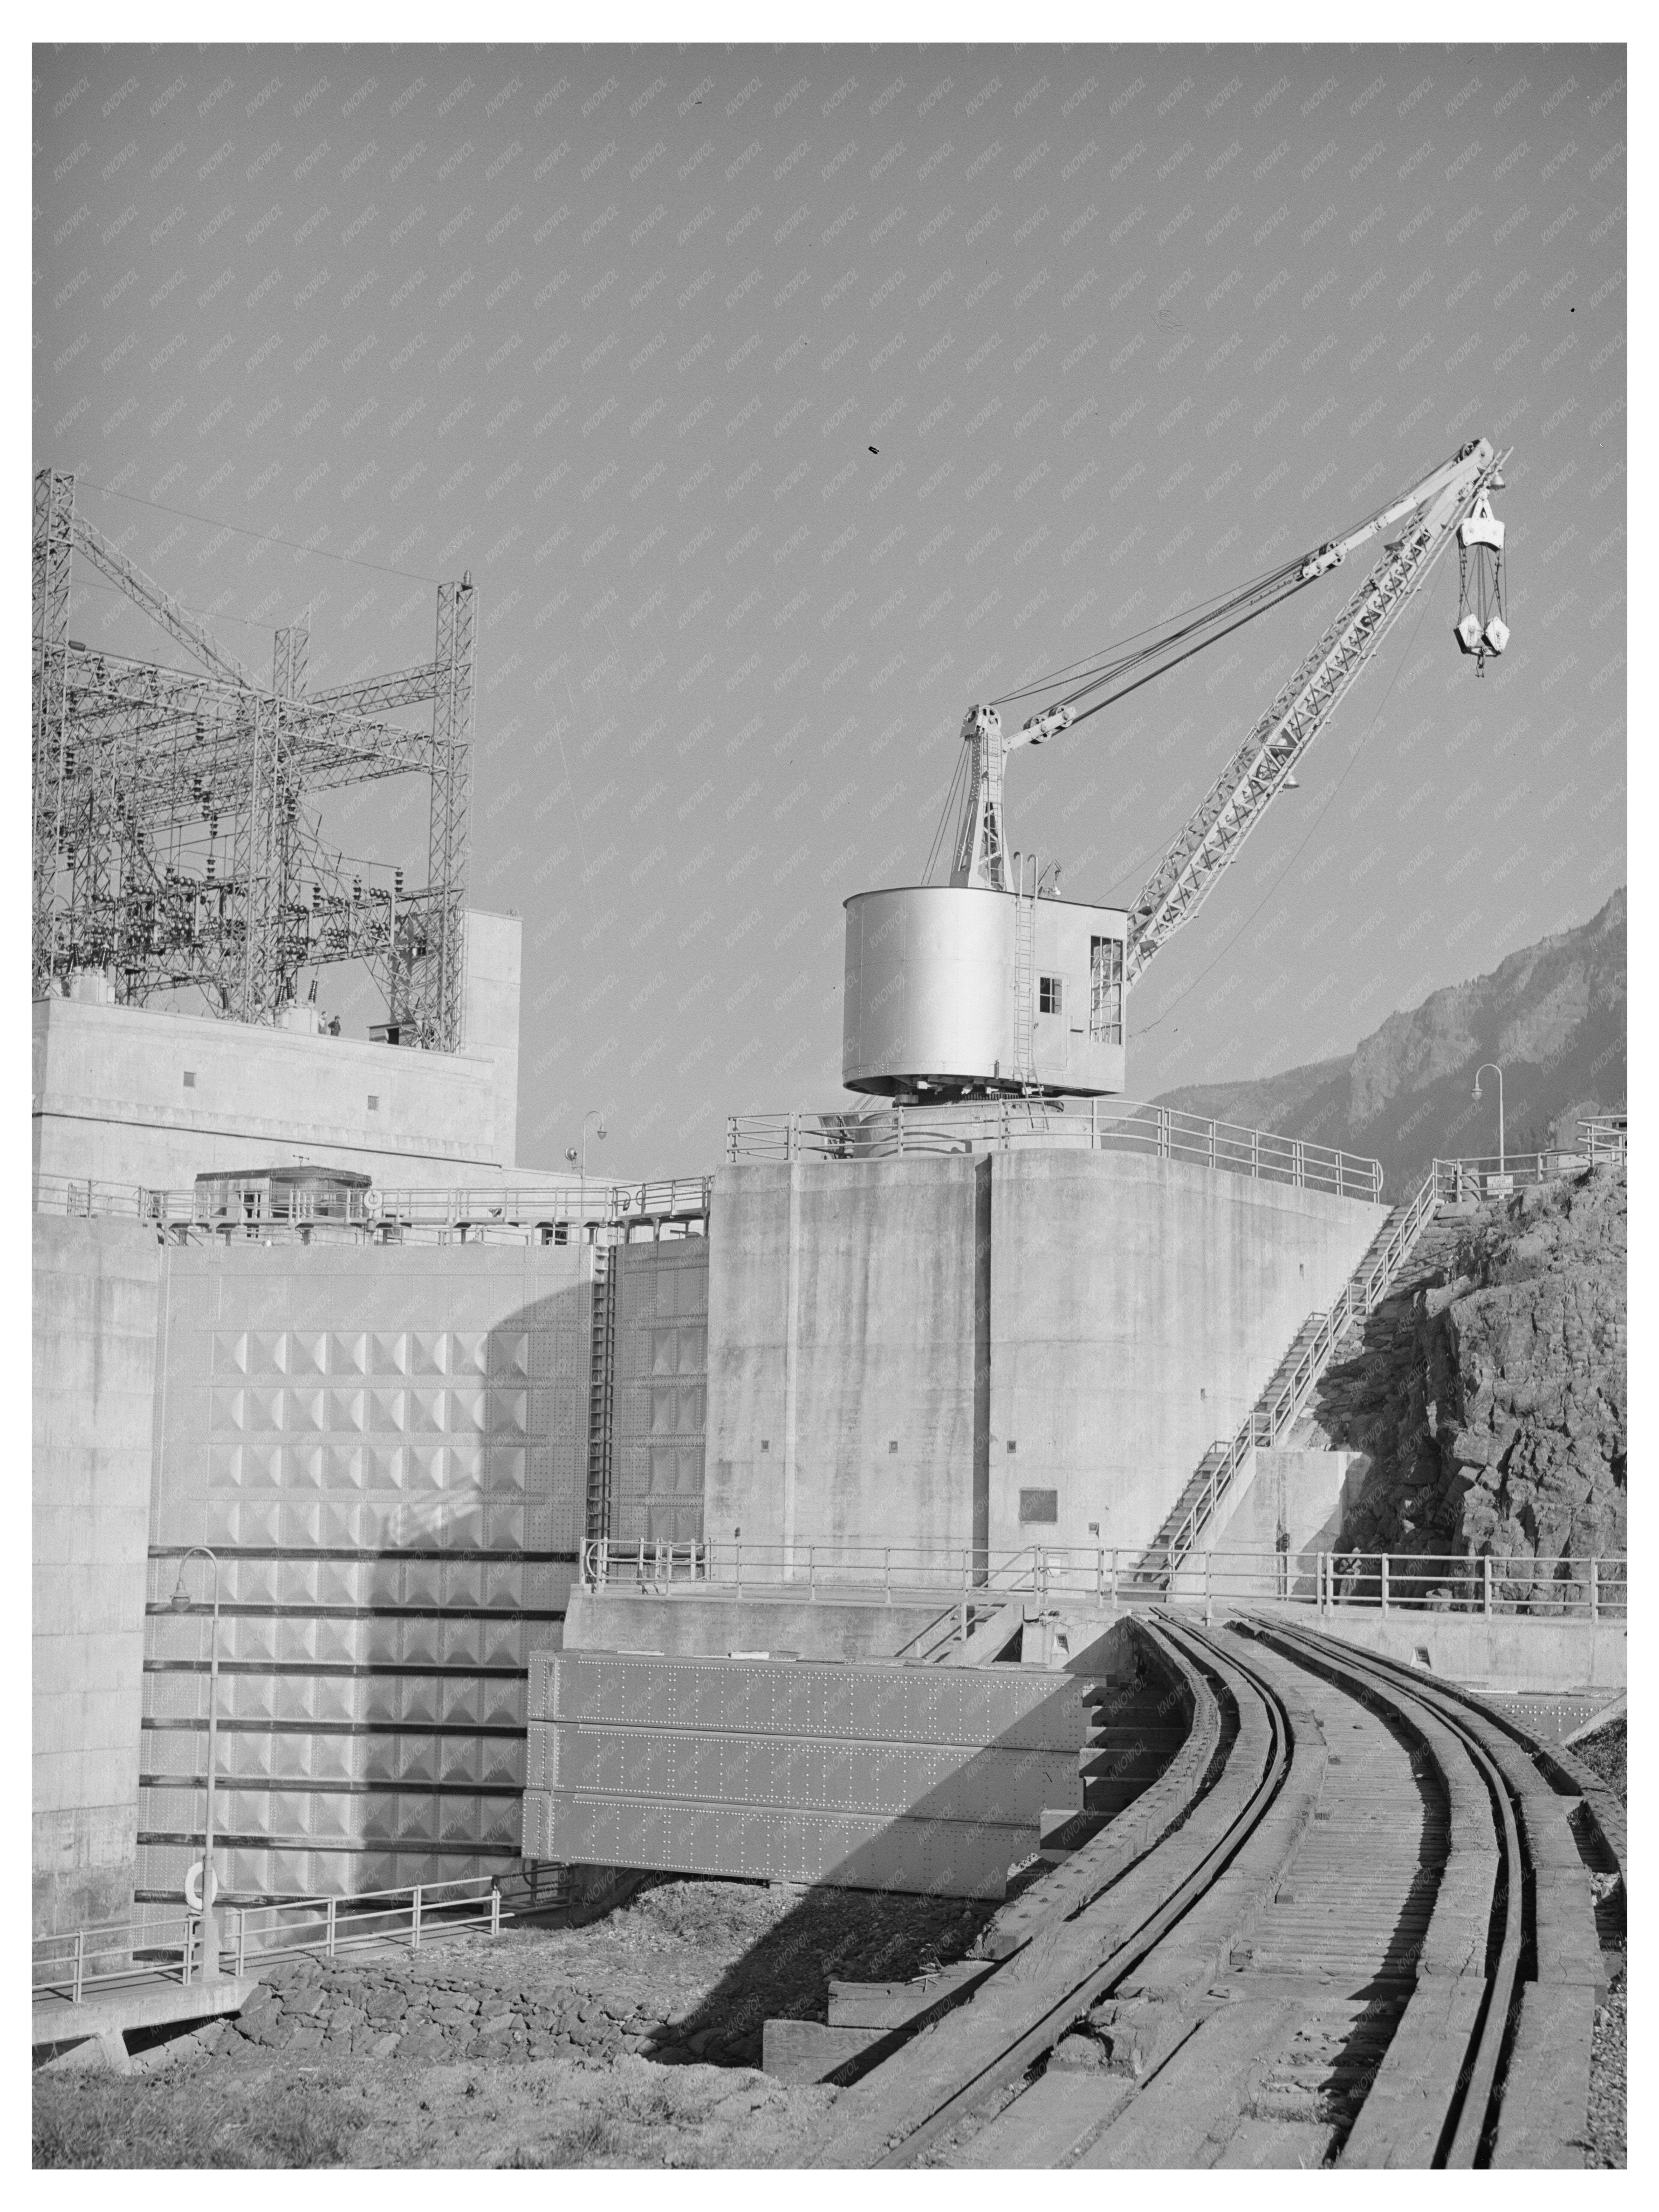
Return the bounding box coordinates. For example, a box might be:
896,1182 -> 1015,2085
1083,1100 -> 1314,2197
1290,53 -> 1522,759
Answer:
1124,438 -> 1500,984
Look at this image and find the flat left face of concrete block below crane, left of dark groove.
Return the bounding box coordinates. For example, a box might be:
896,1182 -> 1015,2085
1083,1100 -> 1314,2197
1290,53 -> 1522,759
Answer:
703,1157 -> 985,1555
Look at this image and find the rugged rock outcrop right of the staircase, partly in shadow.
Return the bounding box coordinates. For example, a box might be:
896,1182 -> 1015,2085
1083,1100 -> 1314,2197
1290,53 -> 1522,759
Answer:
1307,1168 -> 1628,1559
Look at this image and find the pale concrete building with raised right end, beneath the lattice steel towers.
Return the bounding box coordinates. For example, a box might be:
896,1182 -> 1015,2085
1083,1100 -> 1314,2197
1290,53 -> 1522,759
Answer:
33,913 -> 520,1188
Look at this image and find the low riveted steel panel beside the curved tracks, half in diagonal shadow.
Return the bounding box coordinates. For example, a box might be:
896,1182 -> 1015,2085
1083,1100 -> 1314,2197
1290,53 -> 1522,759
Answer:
524,1652 -> 1086,1898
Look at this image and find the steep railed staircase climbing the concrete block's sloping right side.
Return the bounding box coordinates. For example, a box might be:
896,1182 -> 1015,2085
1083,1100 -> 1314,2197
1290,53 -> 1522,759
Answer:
1130,1168 -> 1440,1588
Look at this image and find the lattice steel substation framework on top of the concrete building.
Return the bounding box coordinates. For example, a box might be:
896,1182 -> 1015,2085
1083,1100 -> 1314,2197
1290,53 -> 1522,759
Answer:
33,469 -> 473,1053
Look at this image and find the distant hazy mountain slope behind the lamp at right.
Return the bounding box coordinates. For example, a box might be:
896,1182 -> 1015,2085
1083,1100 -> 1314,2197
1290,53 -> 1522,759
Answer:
1157,889 -> 1626,1199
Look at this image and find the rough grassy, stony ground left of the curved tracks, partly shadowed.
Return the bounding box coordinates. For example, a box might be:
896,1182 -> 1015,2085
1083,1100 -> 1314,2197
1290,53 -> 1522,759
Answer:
33,1880 -> 993,2168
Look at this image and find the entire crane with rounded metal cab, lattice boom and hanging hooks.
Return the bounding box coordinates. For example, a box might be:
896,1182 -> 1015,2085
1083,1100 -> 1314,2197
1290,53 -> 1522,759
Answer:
840,438 -> 1509,1099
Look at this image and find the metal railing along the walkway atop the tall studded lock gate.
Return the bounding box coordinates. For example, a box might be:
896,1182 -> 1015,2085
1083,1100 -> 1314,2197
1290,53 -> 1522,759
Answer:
33,1174 -> 712,1243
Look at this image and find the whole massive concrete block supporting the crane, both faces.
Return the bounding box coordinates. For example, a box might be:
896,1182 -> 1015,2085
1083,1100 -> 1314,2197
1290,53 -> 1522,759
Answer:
706,1148 -> 1385,1553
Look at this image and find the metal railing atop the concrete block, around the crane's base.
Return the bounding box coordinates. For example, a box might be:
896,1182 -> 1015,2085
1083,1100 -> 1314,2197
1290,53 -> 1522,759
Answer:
725,1097 -> 1383,1201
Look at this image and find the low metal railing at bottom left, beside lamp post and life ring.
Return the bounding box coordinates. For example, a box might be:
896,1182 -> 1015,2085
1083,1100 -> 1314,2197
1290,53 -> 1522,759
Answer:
31,1865 -> 568,2004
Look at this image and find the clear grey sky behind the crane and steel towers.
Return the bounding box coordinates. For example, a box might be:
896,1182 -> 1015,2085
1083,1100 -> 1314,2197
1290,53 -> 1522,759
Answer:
31,44 -> 1626,1174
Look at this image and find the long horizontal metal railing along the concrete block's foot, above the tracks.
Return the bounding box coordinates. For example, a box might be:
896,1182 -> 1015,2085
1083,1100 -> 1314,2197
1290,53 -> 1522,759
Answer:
582,1537 -> 1628,1622
